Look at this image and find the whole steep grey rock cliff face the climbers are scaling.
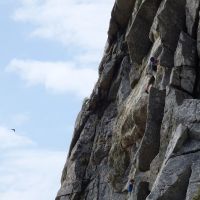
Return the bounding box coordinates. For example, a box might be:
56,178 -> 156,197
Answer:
56,0 -> 200,200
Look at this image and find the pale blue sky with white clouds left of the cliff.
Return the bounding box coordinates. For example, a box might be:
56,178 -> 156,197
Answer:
0,0 -> 114,200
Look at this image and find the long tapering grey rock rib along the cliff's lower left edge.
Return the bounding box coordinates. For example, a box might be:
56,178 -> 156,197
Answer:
57,115 -> 97,196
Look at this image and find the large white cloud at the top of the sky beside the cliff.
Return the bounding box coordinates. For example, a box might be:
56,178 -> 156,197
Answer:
13,0 -> 114,50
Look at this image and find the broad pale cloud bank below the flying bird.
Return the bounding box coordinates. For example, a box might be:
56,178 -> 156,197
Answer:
0,127 -> 66,200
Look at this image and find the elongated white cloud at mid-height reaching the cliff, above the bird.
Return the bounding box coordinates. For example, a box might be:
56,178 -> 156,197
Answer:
7,59 -> 97,97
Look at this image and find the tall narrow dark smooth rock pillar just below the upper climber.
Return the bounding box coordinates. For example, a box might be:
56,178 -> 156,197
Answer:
137,88 -> 166,171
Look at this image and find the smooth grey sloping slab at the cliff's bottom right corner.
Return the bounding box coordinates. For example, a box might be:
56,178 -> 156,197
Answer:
146,155 -> 194,200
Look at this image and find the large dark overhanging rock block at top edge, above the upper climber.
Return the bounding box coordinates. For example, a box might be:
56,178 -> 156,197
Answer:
150,0 -> 186,52
